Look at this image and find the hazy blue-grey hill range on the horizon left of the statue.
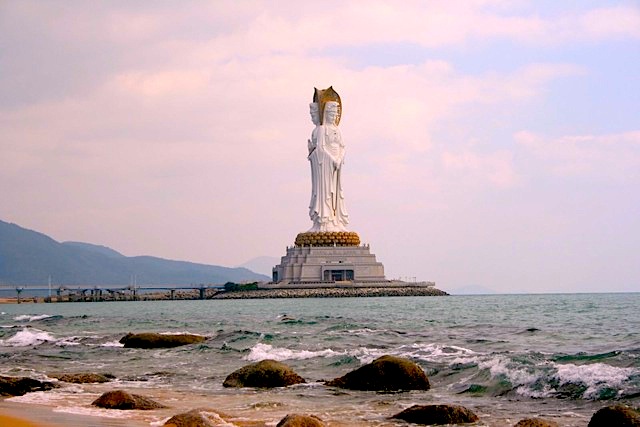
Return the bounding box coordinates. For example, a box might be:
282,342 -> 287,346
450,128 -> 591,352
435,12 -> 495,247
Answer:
0,221 -> 270,285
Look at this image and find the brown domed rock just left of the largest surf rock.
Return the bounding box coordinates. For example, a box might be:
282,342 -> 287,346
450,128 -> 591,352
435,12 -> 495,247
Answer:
222,359 -> 305,388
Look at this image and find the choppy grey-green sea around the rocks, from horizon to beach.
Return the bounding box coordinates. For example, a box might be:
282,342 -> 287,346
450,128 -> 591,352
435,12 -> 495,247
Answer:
0,293 -> 640,426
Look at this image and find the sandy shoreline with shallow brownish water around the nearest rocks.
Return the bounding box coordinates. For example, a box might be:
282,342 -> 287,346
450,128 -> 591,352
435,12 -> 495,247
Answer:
0,383 -> 607,427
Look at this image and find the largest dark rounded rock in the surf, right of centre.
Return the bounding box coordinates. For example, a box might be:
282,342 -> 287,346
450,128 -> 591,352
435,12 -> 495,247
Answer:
326,356 -> 431,391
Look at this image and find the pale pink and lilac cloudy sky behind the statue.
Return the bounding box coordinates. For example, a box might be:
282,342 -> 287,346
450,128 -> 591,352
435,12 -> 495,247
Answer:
0,0 -> 640,292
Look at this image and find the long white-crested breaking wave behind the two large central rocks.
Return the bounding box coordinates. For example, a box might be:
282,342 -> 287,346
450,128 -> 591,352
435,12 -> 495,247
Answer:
244,343 -> 640,400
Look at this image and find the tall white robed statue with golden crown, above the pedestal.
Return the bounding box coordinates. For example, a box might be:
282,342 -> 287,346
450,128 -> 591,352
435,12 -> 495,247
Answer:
308,94 -> 349,232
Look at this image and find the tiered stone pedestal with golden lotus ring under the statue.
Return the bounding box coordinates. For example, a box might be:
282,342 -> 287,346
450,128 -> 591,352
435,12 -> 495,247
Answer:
272,231 -> 387,285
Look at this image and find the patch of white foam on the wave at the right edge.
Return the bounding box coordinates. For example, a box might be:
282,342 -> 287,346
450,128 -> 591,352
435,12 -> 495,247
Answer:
554,363 -> 638,399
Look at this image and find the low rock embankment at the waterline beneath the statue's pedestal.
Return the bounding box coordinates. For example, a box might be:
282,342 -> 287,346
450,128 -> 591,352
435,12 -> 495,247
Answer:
212,286 -> 449,299
